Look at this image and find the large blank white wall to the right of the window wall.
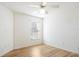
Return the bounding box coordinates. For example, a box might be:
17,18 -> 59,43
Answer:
44,3 -> 79,51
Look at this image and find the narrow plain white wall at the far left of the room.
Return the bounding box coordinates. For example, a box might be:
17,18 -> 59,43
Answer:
0,5 -> 13,56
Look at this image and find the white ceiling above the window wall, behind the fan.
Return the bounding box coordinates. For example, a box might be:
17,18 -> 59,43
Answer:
0,2 -> 58,17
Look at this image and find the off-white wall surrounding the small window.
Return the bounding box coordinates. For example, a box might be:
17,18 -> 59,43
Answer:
15,13 -> 42,49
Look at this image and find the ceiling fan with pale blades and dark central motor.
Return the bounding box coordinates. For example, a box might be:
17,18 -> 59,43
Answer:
27,2 -> 59,14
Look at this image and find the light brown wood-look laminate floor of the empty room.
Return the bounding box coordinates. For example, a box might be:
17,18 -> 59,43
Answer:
3,45 -> 79,57
